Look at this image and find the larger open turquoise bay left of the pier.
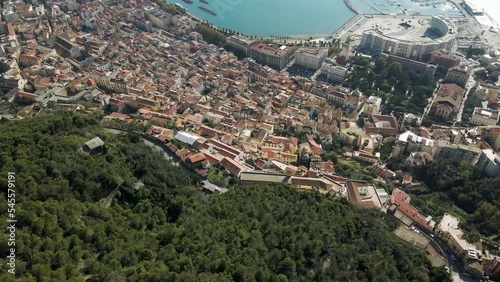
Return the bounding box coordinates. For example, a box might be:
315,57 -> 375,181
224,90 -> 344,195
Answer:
167,0 -> 355,37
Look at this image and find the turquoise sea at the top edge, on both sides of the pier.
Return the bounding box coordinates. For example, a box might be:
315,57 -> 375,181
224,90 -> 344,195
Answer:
166,0 -> 464,37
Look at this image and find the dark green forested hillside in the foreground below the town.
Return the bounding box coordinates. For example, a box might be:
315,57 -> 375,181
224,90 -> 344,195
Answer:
0,113 -> 447,282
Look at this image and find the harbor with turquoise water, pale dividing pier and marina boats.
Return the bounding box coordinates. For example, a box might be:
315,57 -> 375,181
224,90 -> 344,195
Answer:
166,0 -> 465,39
